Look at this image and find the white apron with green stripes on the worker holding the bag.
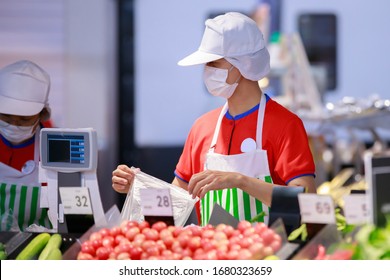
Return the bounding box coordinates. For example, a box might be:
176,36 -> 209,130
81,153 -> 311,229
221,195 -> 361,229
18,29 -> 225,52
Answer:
200,95 -> 272,226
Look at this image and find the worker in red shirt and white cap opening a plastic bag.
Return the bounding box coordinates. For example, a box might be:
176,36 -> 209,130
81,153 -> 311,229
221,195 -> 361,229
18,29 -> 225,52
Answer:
112,12 -> 315,225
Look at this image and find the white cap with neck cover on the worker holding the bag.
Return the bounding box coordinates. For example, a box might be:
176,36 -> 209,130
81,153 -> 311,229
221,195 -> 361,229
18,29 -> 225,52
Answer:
178,12 -> 270,81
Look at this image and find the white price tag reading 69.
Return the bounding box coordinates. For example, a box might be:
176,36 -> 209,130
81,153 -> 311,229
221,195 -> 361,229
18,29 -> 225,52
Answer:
298,193 -> 336,224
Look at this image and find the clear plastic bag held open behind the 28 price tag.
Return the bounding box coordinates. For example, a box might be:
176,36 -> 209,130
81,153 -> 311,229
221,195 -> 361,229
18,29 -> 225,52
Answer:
121,167 -> 199,226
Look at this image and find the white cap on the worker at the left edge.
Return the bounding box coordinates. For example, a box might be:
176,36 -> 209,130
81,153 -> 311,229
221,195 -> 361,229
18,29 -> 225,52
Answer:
0,60 -> 50,116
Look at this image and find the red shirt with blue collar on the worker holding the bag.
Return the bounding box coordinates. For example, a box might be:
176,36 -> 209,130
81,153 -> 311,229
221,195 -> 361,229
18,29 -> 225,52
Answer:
175,95 -> 315,185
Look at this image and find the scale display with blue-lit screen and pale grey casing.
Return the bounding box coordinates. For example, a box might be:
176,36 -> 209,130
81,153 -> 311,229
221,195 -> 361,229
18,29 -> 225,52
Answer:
41,128 -> 97,171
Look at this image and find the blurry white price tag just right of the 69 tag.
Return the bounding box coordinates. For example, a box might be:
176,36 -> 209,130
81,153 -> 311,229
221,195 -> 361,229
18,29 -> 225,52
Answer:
344,194 -> 370,225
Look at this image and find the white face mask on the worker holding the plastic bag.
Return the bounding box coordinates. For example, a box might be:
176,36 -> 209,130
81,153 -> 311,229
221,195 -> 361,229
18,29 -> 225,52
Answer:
203,65 -> 240,99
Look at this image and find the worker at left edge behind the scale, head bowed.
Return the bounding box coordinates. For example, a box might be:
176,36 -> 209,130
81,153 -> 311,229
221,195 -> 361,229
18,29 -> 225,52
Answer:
0,60 -> 51,231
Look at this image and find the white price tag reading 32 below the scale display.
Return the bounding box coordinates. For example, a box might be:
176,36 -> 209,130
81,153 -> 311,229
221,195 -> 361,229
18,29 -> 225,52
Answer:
59,187 -> 92,215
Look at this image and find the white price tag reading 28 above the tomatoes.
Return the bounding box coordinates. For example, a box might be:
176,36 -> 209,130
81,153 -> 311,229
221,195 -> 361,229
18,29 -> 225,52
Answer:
140,188 -> 173,216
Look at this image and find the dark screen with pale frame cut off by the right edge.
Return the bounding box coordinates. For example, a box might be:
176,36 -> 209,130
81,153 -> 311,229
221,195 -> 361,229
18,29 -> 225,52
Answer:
364,152 -> 390,227
